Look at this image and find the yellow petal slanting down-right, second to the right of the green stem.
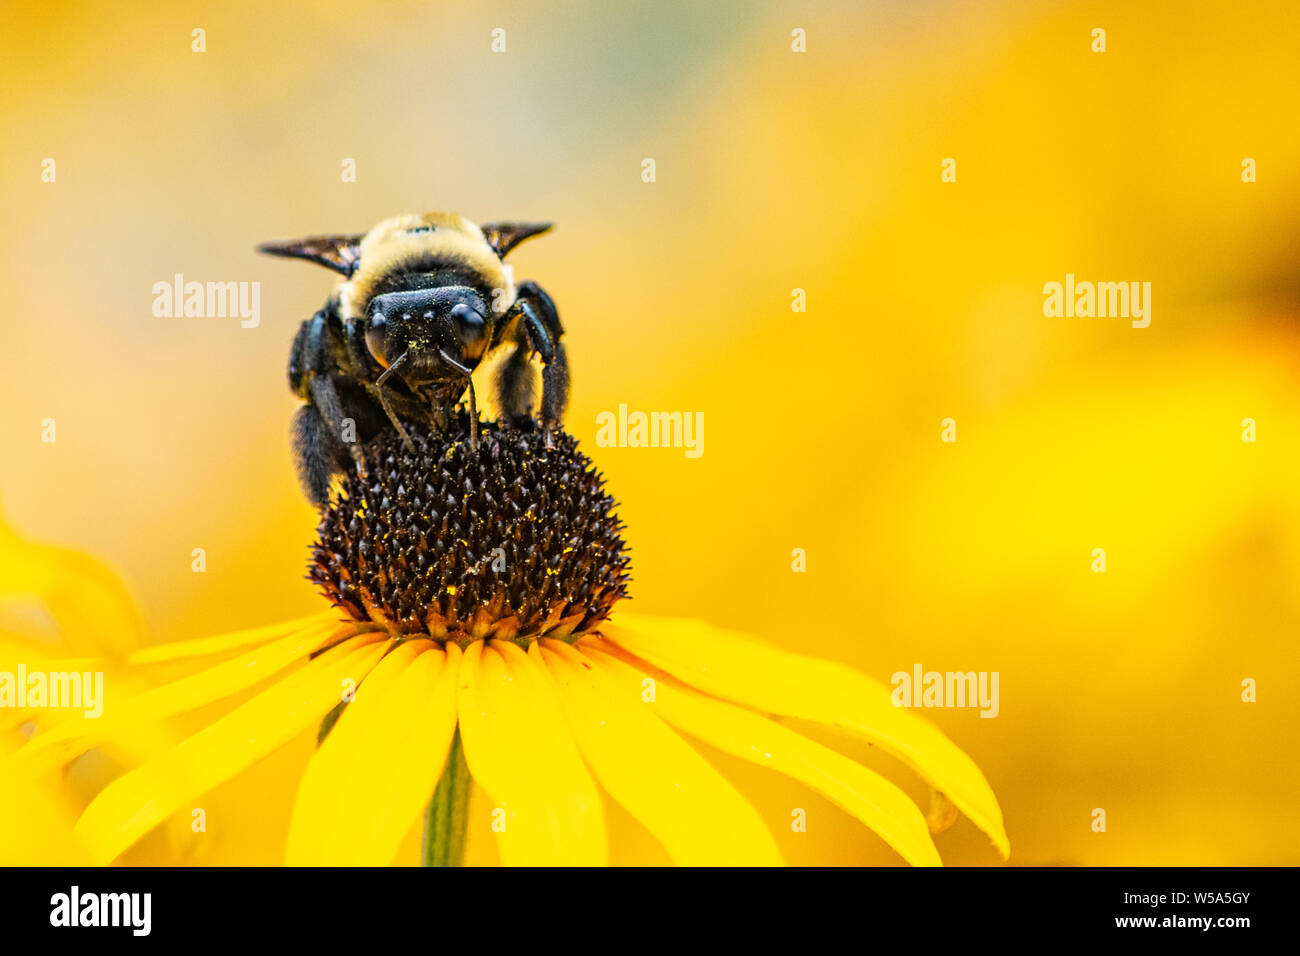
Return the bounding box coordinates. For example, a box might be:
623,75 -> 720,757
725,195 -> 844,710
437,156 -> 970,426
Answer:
533,640 -> 781,866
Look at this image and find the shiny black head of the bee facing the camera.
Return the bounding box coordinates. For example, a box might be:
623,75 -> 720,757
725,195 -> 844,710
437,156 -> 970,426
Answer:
365,286 -> 491,388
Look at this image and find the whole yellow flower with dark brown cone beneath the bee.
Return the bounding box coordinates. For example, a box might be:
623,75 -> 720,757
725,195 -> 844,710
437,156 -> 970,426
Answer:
26,427 -> 1009,865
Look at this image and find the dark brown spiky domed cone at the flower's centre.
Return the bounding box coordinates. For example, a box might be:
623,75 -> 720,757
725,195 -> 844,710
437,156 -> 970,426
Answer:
309,420 -> 629,643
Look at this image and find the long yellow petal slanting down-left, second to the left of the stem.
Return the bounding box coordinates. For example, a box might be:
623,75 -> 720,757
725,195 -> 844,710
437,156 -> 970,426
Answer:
74,635 -> 386,864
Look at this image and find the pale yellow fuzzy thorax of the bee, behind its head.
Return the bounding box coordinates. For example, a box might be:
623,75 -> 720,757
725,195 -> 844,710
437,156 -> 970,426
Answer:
338,212 -> 515,319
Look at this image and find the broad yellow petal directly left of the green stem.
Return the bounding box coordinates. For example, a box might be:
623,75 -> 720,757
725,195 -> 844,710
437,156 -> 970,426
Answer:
285,641 -> 460,866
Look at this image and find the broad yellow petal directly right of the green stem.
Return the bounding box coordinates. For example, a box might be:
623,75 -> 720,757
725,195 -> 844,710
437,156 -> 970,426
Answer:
459,641 -> 607,866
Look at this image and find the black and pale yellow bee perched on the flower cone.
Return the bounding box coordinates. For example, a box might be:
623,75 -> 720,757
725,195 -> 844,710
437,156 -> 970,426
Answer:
257,212 -> 569,505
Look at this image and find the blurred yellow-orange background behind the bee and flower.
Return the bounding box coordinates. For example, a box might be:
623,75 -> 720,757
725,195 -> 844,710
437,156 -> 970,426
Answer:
0,0 -> 1300,865
